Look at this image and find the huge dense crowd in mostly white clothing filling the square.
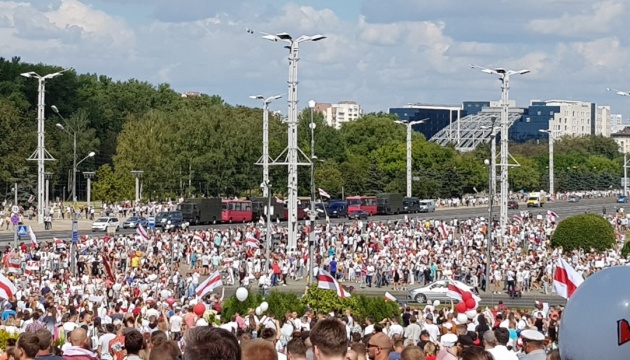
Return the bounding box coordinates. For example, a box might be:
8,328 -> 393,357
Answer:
0,190 -> 627,360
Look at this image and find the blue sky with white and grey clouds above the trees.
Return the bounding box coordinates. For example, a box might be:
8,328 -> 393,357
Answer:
0,0 -> 630,118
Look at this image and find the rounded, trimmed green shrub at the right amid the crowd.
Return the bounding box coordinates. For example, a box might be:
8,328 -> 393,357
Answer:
551,214 -> 616,251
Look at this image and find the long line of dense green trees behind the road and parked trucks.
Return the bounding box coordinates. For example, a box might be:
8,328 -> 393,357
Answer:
0,57 -> 623,202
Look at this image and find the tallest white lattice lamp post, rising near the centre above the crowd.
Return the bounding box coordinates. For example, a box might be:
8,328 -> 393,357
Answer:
256,30 -> 326,249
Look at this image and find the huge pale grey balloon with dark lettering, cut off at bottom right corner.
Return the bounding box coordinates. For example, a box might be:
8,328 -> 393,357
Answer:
558,266 -> 630,360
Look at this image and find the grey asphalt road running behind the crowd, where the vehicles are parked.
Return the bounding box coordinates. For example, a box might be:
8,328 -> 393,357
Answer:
0,198 -> 626,243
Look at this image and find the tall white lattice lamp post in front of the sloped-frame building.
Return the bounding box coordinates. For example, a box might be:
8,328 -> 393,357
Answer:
470,65 -> 529,236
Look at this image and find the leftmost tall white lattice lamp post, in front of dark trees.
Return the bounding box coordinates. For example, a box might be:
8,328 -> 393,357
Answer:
20,70 -> 65,224
